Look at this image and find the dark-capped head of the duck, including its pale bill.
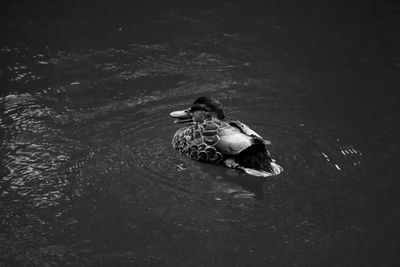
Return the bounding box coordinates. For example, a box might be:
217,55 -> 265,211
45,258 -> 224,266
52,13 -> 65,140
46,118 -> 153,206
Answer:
170,96 -> 225,123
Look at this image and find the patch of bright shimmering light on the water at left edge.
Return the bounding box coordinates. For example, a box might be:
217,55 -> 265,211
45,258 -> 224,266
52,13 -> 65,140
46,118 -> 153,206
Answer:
2,94 -> 66,206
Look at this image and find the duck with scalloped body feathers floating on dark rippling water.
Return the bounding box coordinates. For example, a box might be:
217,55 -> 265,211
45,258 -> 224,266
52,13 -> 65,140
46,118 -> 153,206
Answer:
170,97 -> 283,177
